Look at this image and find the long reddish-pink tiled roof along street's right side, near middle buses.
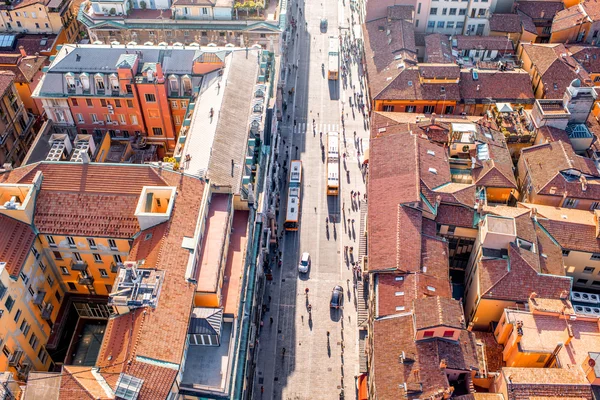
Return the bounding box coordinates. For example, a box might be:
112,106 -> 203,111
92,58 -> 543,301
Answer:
368,120 -> 450,271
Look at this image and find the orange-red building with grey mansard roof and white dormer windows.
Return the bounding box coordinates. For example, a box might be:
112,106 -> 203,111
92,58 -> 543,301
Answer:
34,45 -> 223,156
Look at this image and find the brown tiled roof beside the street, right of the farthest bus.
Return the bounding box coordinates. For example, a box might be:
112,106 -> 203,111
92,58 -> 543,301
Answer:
363,18 -> 417,97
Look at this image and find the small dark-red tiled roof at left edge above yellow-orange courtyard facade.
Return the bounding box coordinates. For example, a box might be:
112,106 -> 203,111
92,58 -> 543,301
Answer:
0,214 -> 36,277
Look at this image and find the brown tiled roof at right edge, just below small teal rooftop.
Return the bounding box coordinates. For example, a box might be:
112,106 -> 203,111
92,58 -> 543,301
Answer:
520,141 -> 600,200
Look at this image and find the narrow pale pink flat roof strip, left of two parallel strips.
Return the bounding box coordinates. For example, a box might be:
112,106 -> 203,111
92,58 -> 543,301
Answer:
196,194 -> 230,293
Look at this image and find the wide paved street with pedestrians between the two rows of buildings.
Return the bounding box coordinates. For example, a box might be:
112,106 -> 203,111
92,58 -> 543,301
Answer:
254,0 -> 368,399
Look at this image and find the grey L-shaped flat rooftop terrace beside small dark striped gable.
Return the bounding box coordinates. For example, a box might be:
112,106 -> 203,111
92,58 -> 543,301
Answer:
181,321 -> 233,392
